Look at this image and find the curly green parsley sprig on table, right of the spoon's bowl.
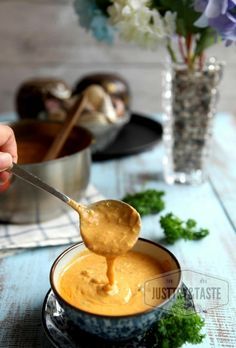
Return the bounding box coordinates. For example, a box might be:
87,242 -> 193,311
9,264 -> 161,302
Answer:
160,213 -> 209,244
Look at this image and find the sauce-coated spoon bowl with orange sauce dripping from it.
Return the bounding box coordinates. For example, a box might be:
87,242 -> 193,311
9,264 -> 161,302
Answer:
68,200 -> 141,291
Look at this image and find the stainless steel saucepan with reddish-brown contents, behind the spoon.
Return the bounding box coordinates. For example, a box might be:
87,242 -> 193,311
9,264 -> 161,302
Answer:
0,120 -> 93,223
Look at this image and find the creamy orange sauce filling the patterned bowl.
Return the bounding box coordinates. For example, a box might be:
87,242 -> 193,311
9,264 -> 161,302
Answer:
59,250 -> 166,316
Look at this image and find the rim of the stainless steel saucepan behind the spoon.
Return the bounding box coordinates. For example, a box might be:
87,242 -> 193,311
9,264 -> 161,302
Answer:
8,118 -> 95,168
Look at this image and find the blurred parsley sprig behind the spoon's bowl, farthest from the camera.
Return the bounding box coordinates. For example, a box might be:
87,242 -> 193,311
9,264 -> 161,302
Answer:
122,189 -> 165,215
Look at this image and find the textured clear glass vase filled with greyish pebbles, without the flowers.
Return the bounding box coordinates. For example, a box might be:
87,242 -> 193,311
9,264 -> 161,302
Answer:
162,58 -> 223,184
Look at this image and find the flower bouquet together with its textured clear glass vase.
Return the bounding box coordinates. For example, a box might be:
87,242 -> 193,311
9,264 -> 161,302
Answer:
74,0 -> 236,184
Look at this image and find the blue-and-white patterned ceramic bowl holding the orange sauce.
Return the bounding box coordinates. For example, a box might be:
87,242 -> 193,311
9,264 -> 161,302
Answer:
50,238 -> 182,341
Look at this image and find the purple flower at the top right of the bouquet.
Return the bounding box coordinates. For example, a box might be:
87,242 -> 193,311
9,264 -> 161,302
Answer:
194,0 -> 236,45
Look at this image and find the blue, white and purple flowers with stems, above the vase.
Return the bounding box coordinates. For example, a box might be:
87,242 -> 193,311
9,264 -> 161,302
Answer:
74,0 -> 236,68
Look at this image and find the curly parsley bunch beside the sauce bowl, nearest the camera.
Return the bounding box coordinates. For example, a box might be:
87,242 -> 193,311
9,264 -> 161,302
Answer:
145,295 -> 205,348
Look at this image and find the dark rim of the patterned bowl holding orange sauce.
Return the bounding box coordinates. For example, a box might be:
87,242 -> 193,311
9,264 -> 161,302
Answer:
49,237 -> 183,320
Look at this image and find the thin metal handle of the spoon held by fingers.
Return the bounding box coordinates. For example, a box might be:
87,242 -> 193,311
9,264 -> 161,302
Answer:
9,163 -> 71,204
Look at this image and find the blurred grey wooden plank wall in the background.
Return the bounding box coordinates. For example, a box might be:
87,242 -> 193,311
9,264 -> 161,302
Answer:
0,0 -> 236,114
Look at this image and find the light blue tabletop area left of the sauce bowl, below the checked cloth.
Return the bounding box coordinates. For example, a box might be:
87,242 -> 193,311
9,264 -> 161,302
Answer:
0,248 -> 63,348
